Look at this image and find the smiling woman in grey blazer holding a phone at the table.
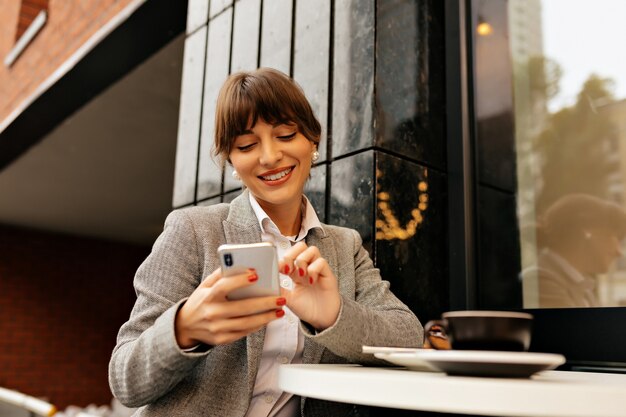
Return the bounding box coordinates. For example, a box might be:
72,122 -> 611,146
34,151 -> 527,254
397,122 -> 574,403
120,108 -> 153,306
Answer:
109,69 -> 423,417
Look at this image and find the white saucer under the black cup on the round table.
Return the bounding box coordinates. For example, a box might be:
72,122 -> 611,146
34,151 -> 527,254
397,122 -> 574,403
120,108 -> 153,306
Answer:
363,346 -> 565,378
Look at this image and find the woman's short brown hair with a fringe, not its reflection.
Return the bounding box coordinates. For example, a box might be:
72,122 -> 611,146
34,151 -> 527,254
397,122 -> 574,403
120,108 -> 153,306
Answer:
214,68 -> 322,160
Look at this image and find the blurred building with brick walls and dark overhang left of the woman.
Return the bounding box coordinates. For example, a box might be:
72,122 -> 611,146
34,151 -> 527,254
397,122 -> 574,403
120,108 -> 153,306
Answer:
0,0 -> 187,414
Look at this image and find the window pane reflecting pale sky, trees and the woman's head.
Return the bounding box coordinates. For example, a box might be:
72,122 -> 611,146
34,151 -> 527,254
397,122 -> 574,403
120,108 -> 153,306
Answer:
504,0 -> 626,308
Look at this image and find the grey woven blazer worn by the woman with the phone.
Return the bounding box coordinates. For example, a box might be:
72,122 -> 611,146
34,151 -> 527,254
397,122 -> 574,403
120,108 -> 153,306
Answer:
109,191 -> 423,417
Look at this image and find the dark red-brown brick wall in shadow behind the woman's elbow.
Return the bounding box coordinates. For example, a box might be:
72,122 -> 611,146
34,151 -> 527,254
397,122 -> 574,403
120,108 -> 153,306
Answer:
0,225 -> 150,409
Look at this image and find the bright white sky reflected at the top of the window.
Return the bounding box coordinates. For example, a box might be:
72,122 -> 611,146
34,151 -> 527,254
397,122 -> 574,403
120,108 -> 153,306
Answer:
542,0 -> 626,109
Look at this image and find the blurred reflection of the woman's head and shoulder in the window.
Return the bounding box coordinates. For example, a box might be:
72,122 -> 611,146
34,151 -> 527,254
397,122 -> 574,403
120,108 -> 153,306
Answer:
522,194 -> 626,308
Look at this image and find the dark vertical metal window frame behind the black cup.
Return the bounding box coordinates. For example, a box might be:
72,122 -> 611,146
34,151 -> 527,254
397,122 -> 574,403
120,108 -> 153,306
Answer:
445,0 -> 477,310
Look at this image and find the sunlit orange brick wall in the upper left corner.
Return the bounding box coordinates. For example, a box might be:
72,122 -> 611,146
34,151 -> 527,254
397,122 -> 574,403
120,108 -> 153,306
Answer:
0,0 -> 133,122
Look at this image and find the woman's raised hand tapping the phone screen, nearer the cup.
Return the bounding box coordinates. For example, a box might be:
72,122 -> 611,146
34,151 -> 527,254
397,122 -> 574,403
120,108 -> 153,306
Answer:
279,242 -> 341,331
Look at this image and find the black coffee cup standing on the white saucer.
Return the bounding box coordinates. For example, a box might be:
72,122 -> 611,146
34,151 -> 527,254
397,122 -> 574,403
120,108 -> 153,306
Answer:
424,311 -> 533,352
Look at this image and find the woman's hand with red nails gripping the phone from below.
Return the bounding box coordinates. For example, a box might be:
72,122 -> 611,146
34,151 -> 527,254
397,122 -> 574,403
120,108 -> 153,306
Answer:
175,268 -> 286,349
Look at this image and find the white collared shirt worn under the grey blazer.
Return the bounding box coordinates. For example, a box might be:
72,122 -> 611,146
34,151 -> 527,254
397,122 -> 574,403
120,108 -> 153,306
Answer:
246,194 -> 322,417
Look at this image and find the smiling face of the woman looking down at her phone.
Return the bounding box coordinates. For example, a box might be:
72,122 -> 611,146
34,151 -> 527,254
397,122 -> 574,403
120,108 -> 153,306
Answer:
229,119 -> 316,211
